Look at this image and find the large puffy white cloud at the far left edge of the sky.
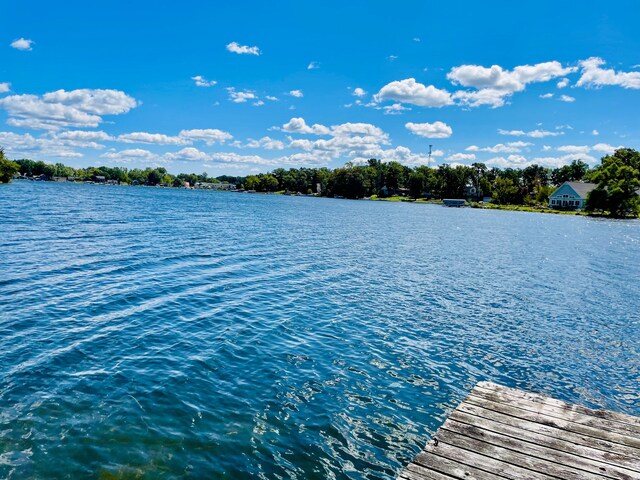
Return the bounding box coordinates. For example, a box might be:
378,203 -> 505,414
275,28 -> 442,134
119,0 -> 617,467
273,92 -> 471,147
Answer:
0,89 -> 138,130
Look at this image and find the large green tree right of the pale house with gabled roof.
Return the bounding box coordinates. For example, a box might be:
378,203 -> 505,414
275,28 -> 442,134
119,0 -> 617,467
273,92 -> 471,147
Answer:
585,148 -> 640,218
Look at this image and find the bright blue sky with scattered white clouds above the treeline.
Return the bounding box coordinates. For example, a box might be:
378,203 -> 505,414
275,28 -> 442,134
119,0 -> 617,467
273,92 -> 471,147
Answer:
0,0 -> 640,175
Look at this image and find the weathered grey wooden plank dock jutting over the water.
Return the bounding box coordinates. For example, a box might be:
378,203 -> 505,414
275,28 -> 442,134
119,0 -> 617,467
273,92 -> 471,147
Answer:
398,382 -> 640,480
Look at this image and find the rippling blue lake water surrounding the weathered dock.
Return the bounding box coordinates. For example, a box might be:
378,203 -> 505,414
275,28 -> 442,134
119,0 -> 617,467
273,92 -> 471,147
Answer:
0,182 -> 640,479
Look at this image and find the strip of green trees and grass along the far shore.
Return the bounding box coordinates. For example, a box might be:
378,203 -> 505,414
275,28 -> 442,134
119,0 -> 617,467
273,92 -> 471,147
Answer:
0,148 -> 640,218
